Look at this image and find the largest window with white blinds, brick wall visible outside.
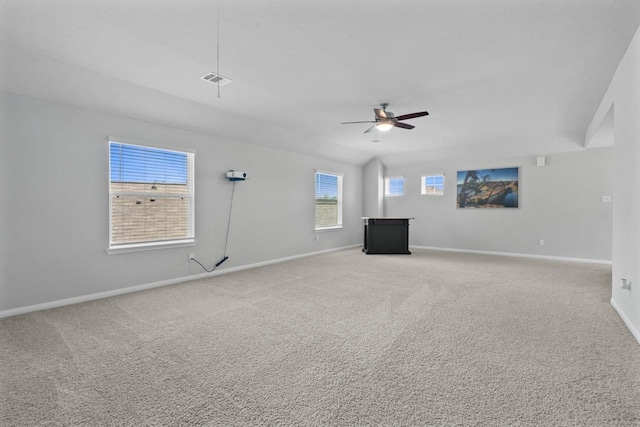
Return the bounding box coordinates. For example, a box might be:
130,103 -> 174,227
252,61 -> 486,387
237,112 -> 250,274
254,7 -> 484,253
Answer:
108,141 -> 195,253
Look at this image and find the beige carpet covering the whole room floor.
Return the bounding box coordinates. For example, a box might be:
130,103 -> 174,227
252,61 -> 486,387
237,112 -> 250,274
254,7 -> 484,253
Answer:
0,249 -> 640,426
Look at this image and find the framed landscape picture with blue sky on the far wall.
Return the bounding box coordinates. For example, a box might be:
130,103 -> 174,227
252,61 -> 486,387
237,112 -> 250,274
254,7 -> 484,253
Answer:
457,168 -> 518,208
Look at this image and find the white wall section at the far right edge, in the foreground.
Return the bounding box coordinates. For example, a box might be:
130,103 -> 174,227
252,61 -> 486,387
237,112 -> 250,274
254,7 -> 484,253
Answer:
587,25 -> 640,341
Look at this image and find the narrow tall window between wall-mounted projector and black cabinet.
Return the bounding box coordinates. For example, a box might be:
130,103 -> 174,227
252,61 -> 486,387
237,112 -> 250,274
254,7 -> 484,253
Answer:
316,172 -> 342,230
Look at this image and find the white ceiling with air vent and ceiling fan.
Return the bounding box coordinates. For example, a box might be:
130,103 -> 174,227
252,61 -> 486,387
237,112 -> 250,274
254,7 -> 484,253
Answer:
0,0 -> 640,165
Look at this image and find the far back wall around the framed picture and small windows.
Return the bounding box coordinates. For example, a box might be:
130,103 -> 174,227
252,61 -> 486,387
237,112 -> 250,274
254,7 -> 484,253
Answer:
385,148 -> 613,261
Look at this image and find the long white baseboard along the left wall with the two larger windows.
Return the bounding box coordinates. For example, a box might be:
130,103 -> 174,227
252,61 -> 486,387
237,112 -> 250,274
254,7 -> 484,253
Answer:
0,244 -> 362,319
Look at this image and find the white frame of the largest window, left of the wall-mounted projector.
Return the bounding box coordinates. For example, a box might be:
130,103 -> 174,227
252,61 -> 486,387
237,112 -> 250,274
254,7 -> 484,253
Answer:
106,136 -> 197,255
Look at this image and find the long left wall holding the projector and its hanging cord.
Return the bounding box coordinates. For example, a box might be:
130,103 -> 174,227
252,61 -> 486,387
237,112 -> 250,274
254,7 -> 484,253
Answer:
0,92 -> 363,312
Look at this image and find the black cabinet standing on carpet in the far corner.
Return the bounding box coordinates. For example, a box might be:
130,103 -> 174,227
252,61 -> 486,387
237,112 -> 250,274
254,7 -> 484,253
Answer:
362,218 -> 413,255
